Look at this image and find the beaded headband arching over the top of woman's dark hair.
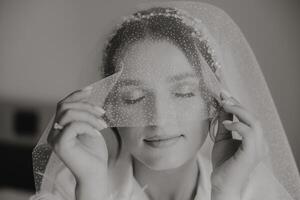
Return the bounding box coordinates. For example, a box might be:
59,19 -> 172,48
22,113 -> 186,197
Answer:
103,7 -> 221,124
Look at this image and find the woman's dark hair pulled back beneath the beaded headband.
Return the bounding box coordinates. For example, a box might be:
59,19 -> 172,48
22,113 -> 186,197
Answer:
102,7 -> 220,157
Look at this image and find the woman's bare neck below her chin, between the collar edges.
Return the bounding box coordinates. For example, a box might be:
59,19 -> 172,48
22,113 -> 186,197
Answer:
133,158 -> 199,200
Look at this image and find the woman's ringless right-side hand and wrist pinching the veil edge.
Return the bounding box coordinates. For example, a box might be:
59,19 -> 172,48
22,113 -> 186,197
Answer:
211,92 -> 268,200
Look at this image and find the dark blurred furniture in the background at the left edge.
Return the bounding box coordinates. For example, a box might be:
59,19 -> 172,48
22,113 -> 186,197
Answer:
0,100 -> 54,200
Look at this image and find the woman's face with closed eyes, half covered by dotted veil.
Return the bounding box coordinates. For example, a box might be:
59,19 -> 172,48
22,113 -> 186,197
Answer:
114,39 -> 208,170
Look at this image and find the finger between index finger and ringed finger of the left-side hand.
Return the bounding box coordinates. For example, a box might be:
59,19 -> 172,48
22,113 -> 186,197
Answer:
57,102 -> 105,117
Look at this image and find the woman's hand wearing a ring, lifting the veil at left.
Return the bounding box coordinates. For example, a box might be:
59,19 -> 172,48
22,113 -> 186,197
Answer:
47,87 -> 108,199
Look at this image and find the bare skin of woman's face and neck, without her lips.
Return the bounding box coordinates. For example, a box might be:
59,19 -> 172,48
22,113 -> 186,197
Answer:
113,40 -> 208,199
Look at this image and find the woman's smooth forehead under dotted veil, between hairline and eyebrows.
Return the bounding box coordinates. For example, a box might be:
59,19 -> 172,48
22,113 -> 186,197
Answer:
119,39 -> 194,82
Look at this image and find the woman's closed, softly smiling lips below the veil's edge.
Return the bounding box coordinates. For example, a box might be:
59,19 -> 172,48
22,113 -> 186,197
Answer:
144,135 -> 183,148
